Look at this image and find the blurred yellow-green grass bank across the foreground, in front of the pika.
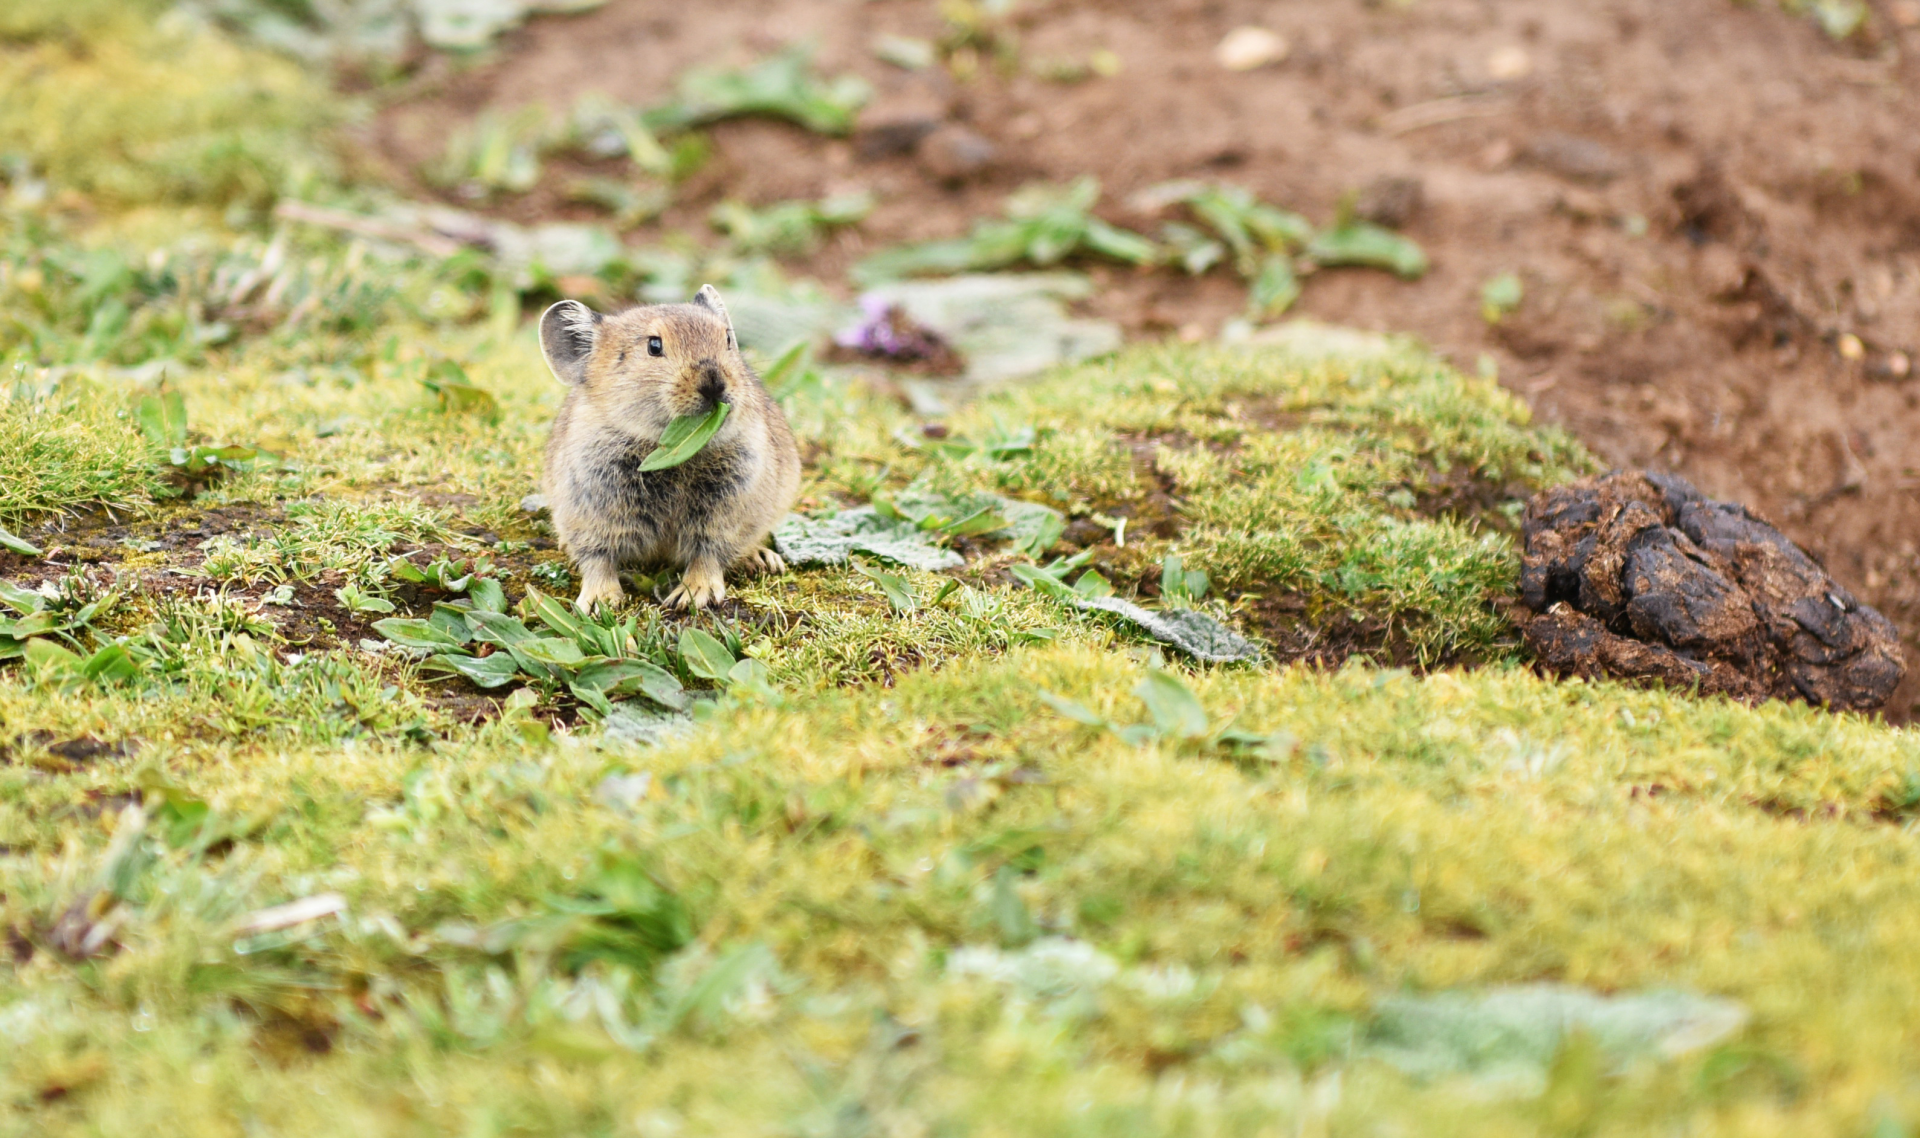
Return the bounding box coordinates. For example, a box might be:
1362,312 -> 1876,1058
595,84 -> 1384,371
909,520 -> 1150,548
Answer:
0,649 -> 1920,1134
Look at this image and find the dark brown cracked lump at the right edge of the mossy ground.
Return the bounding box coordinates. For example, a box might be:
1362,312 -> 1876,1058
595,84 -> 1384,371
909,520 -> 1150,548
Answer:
1521,472 -> 1907,712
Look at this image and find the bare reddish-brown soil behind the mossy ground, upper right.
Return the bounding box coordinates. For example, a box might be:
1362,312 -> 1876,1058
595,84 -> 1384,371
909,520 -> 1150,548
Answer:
361,0 -> 1920,714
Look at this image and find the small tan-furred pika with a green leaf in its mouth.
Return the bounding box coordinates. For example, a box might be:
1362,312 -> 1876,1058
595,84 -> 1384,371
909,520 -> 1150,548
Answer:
540,284 -> 801,610
